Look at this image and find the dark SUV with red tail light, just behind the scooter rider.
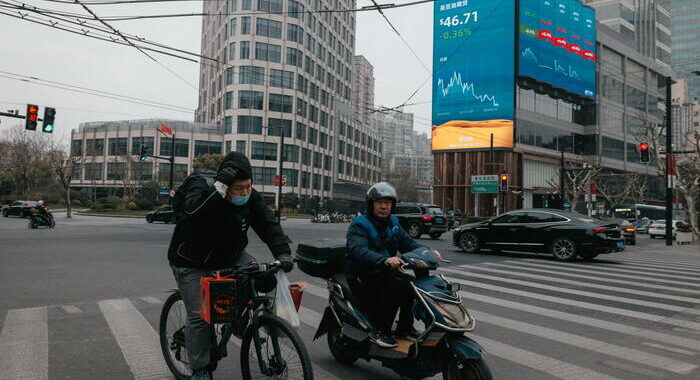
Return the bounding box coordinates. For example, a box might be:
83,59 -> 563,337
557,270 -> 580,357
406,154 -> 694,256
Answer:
394,203 -> 447,239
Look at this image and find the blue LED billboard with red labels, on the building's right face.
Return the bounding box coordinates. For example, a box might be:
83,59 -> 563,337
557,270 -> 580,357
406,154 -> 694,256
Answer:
519,0 -> 596,98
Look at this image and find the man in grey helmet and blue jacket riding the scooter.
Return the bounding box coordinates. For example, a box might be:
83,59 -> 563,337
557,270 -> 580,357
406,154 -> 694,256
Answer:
345,182 -> 423,347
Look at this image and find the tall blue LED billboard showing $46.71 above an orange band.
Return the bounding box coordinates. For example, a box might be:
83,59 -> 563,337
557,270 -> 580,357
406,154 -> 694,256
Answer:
432,0 -> 516,151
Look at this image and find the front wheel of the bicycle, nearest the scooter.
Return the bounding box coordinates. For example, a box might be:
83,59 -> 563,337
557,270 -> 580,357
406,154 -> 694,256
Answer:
241,315 -> 314,380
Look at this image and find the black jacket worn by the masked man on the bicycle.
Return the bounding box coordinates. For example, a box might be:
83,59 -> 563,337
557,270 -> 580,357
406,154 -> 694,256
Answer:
168,154 -> 291,270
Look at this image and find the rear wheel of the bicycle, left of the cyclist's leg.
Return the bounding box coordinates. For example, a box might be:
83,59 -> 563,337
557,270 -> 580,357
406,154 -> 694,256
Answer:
159,292 -> 192,380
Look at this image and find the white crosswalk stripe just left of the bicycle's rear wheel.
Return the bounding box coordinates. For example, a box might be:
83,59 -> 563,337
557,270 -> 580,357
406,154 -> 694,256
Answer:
98,298 -> 172,380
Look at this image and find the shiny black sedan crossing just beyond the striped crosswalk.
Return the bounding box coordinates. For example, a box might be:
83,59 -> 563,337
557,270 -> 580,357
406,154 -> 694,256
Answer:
453,209 -> 625,261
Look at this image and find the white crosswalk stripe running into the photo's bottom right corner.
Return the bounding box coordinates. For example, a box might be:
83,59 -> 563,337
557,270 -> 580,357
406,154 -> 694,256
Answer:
472,309 -> 697,375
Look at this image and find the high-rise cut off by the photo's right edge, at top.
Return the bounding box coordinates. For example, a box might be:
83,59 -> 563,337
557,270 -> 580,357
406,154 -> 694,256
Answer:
671,0 -> 700,102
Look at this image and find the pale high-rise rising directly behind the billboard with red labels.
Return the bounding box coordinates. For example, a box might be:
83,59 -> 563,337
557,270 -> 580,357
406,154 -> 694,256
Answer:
584,0 -> 676,65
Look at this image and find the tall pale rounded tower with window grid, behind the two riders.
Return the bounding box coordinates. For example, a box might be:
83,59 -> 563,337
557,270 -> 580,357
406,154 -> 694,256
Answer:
196,0 -> 380,208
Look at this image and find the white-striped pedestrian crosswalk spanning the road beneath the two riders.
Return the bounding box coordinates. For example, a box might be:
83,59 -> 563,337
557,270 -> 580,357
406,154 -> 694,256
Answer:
0,257 -> 700,380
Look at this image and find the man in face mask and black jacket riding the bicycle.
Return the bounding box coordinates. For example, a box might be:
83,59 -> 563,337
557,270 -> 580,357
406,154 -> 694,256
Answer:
168,152 -> 294,380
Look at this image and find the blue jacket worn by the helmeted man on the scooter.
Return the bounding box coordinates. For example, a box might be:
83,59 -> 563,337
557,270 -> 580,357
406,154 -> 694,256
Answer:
345,215 -> 423,277
